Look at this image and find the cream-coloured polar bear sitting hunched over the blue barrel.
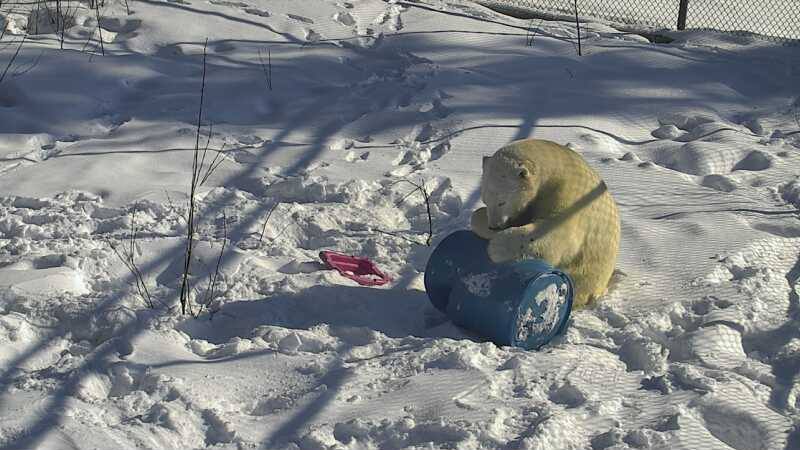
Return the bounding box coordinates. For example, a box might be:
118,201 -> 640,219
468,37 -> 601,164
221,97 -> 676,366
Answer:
471,139 -> 620,308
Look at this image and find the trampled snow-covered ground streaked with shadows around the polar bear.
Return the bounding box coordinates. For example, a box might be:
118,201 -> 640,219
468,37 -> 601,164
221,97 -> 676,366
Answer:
0,0 -> 800,450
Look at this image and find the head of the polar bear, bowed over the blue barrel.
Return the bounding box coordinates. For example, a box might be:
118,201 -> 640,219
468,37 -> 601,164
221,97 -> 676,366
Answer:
481,152 -> 539,230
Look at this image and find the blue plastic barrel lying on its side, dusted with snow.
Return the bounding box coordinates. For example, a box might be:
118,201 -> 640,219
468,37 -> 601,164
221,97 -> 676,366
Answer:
425,230 -> 574,349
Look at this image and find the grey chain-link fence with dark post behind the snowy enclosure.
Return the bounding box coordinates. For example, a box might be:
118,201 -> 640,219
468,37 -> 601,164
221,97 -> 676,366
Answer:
479,0 -> 800,43
